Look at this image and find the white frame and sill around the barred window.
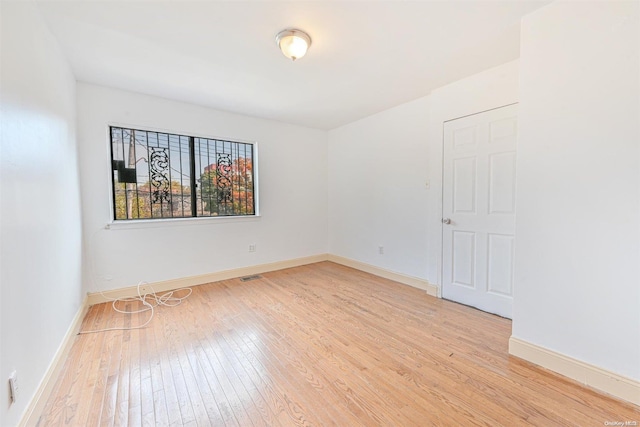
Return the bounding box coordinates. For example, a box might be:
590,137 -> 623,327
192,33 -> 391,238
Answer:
105,122 -> 261,229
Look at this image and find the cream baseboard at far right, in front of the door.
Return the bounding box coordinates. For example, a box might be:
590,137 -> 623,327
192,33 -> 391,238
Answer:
509,336 -> 640,405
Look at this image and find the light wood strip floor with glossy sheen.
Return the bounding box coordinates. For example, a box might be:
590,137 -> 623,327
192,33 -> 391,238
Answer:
39,262 -> 640,426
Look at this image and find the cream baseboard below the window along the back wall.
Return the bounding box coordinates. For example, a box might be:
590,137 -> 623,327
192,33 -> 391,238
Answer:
88,254 -> 328,305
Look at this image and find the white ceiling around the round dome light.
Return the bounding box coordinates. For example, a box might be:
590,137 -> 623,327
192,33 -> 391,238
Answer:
39,0 -> 549,129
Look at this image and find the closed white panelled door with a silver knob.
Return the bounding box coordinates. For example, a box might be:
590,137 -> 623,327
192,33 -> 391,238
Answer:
442,105 -> 518,318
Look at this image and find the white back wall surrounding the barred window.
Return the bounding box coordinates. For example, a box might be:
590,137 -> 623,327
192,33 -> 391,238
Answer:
77,83 -> 327,291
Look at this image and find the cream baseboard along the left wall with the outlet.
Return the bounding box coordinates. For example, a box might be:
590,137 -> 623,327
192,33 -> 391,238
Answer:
18,297 -> 89,427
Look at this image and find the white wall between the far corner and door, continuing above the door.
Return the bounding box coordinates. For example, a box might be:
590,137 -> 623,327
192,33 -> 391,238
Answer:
329,61 -> 518,285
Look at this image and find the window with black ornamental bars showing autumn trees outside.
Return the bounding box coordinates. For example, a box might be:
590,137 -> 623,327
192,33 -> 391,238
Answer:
110,127 -> 256,220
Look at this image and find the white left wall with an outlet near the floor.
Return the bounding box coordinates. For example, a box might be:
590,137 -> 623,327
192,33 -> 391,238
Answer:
0,2 -> 82,426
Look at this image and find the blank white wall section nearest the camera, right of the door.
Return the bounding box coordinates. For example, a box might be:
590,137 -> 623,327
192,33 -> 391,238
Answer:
513,2 -> 640,380
